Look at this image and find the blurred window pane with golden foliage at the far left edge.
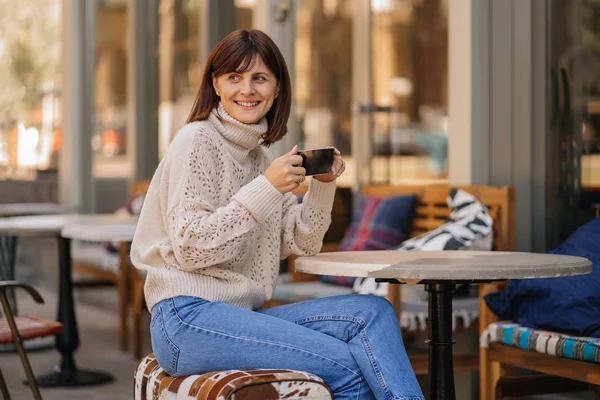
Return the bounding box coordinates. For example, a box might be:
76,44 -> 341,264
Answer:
0,0 -> 61,179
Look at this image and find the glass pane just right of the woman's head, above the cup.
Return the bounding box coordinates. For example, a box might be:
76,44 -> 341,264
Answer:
294,0 -> 352,154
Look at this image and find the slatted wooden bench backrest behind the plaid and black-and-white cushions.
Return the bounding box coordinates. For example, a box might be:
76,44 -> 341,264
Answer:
361,185 -> 516,251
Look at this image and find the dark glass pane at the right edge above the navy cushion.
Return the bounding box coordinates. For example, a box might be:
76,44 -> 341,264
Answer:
544,0 -> 600,249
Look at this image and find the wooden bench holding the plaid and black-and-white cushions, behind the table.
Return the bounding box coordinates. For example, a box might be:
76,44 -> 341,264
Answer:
278,185 -> 516,375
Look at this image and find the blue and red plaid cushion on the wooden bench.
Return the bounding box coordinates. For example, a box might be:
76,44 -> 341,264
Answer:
321,195 -> 417,286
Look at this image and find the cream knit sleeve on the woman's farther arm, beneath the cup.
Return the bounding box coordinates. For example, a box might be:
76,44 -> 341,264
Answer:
281,179 -> 335,259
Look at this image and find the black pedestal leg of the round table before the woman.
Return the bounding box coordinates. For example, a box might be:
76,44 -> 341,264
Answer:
425,282 -> 456,400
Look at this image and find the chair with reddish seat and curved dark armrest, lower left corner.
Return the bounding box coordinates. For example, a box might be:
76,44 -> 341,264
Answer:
0,281 -> 63,400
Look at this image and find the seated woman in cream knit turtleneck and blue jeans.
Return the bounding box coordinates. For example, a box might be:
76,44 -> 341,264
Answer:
131,30 -> 423,399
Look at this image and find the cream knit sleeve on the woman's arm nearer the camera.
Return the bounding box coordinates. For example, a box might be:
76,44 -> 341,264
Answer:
168,138 -> 283,272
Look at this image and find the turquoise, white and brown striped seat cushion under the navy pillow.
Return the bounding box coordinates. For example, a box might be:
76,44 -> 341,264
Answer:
481,322 -> 600,364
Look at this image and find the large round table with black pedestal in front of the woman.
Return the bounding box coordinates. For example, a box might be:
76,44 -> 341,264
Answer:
296,250 -> 592,400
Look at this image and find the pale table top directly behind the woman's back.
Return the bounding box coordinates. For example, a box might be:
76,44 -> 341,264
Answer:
61,218 -> 137,242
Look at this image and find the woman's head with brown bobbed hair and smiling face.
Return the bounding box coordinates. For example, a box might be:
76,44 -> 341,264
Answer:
187,30 -> 292,146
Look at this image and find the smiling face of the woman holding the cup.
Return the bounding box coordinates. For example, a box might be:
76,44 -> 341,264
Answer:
213,57 -> 279,124
